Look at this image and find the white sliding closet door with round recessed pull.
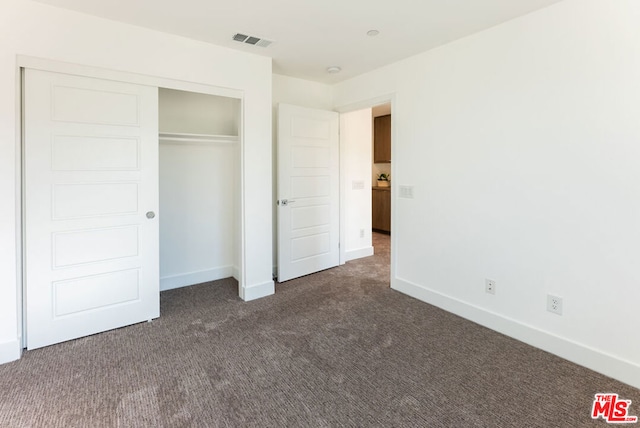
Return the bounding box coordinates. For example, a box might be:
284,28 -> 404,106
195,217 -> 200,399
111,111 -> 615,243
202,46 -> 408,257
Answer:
24,70 -> 160,349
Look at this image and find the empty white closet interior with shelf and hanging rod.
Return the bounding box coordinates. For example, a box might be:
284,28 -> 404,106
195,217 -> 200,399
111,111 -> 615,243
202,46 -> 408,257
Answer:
158,88 -> 241,290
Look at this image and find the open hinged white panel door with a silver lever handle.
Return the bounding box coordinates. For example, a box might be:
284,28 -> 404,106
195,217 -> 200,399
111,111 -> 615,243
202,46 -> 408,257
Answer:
278,104 -> 340,282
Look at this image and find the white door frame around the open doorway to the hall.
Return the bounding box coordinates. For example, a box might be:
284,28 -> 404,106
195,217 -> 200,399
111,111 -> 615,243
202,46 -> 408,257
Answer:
334,93 -> 397,284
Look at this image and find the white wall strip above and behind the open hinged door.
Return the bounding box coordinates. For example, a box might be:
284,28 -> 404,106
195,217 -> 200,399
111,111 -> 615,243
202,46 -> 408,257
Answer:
271,74 -> 333,276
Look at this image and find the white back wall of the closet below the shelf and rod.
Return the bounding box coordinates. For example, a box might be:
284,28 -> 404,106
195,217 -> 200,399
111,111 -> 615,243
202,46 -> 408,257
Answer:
159,142 -> 238,290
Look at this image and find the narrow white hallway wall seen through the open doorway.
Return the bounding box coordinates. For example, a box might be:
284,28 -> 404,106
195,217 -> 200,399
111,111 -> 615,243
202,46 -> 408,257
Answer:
340,108 -> 373,261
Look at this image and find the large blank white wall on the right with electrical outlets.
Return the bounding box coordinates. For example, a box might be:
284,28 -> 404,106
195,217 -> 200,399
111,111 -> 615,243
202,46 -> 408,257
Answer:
334,0 -> 640,387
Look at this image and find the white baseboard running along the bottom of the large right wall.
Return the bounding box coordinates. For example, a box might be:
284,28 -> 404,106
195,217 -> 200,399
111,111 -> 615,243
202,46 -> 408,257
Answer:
391,278 -> 640,388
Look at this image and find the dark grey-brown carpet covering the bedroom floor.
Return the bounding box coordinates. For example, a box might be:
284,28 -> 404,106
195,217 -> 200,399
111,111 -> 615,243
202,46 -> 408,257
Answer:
0,235 -> 640,427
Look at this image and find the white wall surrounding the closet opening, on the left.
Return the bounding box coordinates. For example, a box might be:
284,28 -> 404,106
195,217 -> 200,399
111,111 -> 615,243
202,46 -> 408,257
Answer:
0,0 -> 274,362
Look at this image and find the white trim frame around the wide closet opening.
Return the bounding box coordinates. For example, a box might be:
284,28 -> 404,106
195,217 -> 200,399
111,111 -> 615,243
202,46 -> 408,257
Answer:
16,55 -> 247,349
